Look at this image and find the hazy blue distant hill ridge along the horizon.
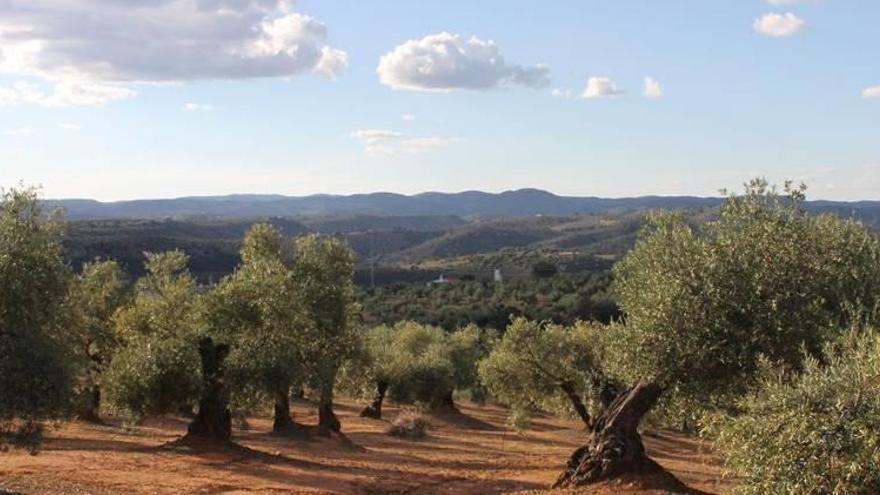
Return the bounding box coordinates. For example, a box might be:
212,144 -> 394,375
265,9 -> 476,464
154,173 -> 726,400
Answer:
46,189 -> 880,232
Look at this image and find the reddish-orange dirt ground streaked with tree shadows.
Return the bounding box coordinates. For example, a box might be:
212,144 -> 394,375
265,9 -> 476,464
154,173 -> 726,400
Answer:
0,401 -> 727,495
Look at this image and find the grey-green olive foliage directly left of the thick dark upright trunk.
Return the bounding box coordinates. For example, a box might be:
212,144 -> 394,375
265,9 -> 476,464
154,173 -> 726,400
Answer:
105,251 -> 203,420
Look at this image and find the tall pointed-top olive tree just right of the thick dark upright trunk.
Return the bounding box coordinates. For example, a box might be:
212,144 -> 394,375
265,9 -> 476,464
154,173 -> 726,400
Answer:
205,224 -> 312,431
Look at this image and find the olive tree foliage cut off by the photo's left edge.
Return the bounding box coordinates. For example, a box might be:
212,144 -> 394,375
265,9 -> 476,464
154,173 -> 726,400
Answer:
0,189 -> 74,450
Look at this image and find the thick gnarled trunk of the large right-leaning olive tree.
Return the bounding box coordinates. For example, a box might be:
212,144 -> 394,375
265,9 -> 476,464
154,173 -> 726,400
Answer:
553,381 -> 663,488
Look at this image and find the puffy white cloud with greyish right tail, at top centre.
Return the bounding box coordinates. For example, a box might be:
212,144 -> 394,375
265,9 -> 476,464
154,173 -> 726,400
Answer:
376,32 -> 549,91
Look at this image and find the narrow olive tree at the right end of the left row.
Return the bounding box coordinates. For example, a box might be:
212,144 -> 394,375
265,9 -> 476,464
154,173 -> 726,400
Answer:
292,234 -> 360,432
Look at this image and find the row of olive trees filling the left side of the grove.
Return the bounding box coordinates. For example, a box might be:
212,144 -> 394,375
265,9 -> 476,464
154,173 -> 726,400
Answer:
0,190 -> 361,446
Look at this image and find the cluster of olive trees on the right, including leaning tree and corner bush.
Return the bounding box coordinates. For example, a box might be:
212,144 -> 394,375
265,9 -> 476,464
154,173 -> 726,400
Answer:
480,181 -> 880,493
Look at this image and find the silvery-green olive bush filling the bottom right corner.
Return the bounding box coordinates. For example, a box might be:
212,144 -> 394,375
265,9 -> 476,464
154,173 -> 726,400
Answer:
709,331 -> 880,495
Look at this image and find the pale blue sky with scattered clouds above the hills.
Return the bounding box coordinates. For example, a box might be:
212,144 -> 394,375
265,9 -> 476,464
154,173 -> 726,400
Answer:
0,0 -> 880,200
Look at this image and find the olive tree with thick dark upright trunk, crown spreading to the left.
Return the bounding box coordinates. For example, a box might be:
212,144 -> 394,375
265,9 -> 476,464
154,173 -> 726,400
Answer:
106,251 -> 231,441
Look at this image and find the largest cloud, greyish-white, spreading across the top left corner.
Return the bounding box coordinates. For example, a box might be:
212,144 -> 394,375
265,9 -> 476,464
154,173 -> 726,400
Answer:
0,0 -> 347,105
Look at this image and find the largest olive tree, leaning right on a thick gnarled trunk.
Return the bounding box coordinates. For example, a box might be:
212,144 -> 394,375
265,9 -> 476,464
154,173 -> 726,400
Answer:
557,180 -> 880,486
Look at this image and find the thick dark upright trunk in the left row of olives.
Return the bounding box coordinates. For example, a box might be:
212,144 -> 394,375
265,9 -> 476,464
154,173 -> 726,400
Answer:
187,337 -> 232,442
